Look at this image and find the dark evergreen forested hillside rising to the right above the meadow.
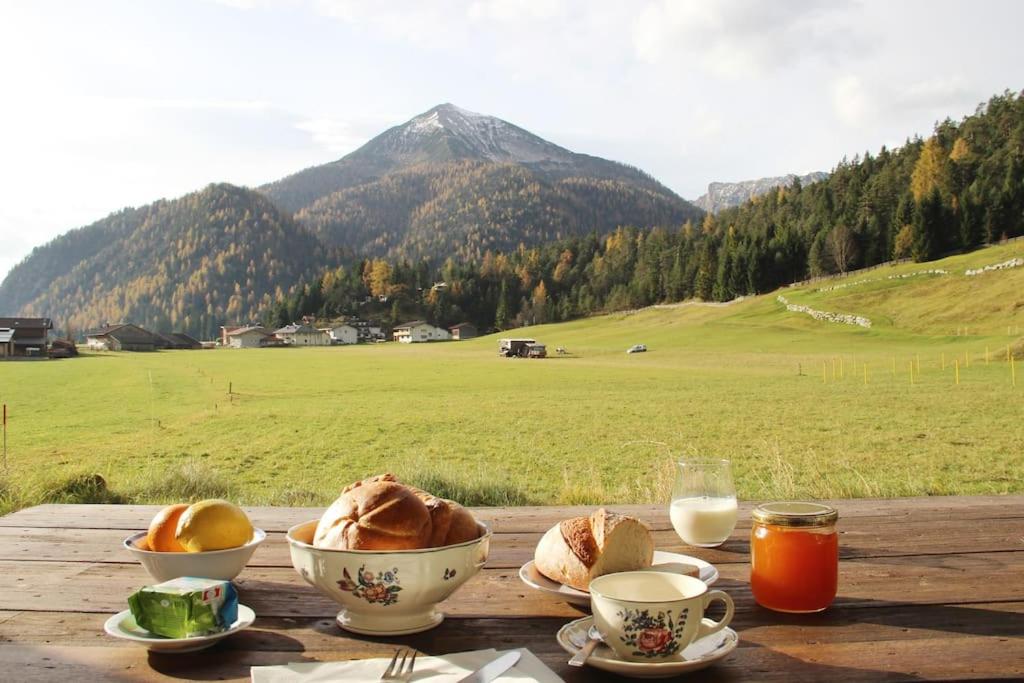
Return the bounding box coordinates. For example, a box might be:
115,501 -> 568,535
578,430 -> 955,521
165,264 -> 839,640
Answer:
269,92 -> 1024,329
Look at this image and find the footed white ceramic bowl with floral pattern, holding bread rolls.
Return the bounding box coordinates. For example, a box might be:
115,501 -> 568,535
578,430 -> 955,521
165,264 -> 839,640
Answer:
288,519 -> 490,636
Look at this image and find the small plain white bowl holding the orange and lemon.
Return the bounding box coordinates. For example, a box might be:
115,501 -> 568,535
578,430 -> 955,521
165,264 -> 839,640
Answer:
124,528 -> 266,584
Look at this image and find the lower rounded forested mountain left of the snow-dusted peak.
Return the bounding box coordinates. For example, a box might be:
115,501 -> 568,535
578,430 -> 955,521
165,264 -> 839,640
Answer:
0,184 -> 325,338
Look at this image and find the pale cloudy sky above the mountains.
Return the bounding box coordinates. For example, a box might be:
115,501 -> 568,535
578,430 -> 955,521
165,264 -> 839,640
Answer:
0,0 -> 1024,279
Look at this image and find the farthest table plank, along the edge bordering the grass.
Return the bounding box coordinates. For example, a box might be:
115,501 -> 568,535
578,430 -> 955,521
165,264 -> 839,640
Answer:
0,496 -> 1024,532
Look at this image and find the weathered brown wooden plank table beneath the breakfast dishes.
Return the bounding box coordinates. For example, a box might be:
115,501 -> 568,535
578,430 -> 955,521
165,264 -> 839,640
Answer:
0,496 -> 1024,682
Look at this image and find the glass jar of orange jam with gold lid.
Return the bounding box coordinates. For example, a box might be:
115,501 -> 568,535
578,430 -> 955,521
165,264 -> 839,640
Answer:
751,503 -> 839,612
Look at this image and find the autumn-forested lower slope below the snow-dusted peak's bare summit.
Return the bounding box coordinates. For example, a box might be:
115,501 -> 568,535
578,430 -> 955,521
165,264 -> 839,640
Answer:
296,161 -> 699,261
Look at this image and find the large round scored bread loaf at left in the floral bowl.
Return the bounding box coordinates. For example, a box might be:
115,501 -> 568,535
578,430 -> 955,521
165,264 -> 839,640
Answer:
313,477 -> 432,550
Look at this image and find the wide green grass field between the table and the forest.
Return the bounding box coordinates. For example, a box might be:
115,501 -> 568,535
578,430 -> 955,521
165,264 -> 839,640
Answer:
0,243 -> 1024,509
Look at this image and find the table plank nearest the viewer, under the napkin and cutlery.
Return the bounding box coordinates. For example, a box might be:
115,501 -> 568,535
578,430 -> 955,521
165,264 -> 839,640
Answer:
0,633 -> 1024,683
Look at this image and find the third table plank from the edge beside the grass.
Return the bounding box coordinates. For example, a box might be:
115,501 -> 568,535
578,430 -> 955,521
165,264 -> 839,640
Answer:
0,552 -> 1024,618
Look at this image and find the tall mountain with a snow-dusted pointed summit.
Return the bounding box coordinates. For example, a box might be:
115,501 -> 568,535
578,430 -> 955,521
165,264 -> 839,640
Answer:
259,104 -> 700,259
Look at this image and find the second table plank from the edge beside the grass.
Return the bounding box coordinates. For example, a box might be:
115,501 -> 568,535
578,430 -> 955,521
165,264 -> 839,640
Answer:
0,517 -> 1024,568
